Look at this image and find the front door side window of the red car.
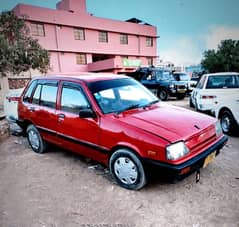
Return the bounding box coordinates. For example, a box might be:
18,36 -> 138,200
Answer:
61,87 -> 90,114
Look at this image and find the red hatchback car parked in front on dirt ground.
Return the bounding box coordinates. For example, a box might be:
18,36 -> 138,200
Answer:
17,74 -> 227,190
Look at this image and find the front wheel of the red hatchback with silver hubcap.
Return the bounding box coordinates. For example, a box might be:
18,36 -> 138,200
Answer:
109,149 -> 147,190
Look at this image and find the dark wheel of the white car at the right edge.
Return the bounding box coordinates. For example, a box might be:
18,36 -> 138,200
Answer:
220,110 -> 236,135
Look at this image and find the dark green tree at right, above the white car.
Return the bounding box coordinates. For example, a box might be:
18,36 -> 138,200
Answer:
201,39 -> 239,73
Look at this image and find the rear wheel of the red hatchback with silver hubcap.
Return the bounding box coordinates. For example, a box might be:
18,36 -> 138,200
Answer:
26,125 -> 46,153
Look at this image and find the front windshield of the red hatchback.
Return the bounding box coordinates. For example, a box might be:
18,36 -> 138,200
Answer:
89,78 -> 158,114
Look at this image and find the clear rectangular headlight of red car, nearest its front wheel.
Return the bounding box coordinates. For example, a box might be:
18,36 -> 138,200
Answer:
166,141 -> 189,160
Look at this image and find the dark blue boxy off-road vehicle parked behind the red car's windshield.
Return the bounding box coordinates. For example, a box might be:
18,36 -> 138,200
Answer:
130,67 -> 187,101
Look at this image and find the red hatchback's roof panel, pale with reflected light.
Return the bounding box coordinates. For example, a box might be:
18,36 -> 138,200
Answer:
34,72 -> 129,83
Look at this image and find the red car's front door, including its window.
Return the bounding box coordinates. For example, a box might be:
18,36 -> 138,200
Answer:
57,82 -> 105,161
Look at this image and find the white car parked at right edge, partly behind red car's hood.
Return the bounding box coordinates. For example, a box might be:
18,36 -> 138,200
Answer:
190,72 -> 239,134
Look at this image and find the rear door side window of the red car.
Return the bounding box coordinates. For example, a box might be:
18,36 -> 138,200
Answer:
40,84 -> 57,108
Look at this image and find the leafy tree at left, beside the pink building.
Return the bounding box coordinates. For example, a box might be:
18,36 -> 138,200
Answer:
0,11 -> 50,75
